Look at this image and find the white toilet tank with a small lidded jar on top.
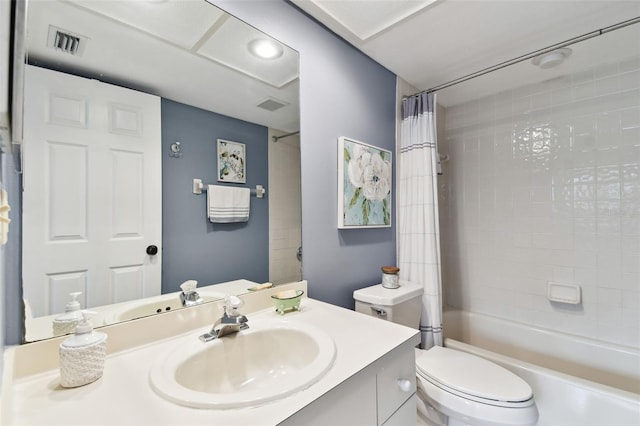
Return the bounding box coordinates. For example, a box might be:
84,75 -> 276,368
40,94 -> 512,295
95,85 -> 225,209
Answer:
353,281 -> 422,329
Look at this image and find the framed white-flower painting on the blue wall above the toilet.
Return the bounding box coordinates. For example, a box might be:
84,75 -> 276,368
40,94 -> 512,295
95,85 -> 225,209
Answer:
338,137 -> 392,229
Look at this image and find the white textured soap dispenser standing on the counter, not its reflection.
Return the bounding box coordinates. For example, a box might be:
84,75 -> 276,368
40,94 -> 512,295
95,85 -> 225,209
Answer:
60,311 -> 107,388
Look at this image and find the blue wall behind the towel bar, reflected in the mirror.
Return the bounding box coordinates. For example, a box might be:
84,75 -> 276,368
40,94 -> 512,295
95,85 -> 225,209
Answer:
162,99 -> 269,293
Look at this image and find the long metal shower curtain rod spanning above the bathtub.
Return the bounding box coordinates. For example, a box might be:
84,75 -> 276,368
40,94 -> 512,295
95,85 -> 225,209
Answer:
403,16 -> 640,99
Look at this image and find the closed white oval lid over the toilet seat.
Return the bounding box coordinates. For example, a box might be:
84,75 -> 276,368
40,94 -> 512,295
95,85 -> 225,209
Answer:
416,346 -> 533,405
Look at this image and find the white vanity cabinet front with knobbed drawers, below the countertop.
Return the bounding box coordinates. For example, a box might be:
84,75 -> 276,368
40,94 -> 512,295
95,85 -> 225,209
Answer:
280,341 -> 416,426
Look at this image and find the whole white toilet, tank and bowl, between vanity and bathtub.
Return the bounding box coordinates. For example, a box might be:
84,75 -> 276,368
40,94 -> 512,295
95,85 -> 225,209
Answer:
353,282 -> 538,426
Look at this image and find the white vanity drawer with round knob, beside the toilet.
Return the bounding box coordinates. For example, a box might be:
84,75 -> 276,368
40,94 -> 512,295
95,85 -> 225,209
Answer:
376,344 -> 416,424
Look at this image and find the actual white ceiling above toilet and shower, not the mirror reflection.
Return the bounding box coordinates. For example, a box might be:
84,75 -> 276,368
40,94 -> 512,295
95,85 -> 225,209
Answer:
292,0 -> 640,106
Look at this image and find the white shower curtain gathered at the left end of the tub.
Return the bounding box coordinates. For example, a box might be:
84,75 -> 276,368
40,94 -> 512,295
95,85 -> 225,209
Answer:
398,93 -> 443,349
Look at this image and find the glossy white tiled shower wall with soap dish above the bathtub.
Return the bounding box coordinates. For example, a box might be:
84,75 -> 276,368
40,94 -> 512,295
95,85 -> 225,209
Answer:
439,57 -> 640,348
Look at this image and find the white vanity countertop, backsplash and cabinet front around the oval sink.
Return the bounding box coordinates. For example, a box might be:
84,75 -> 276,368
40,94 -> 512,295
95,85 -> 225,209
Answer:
0,290 -> 420,426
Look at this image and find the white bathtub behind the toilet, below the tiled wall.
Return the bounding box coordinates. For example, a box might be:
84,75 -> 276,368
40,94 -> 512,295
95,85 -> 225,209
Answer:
443,310 -> 640,426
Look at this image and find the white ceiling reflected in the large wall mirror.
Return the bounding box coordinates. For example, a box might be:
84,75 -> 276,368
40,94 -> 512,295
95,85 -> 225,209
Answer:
27,0 -> 300,131
